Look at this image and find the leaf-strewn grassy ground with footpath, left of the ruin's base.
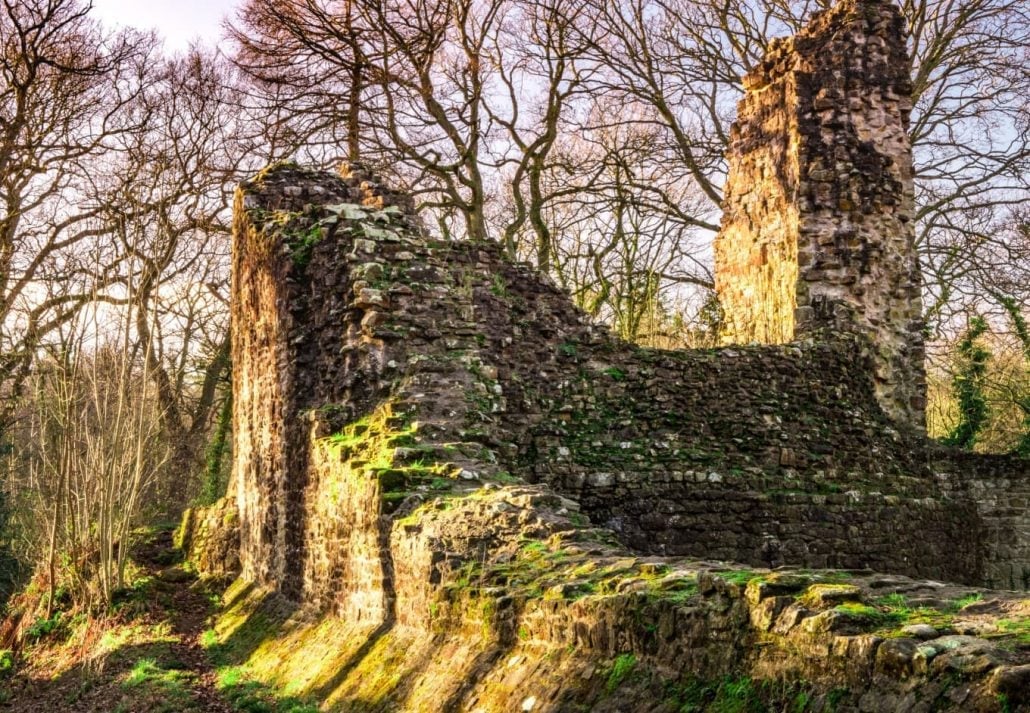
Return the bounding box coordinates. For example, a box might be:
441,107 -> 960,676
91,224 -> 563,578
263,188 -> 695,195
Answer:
0,528 -> 317,713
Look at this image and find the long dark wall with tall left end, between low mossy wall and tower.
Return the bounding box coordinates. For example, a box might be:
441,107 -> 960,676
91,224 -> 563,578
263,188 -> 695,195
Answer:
235,162 -> 1026,597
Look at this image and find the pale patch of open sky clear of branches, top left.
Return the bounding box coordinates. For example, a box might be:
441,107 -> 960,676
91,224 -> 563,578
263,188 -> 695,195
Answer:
93,0 -> 241,50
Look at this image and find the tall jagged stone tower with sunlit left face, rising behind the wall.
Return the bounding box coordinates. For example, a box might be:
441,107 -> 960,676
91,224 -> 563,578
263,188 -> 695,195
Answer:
715,0 -> 926,430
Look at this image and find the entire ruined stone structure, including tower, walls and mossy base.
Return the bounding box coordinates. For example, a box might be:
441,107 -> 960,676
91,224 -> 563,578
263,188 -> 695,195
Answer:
180,0 -> 1030,713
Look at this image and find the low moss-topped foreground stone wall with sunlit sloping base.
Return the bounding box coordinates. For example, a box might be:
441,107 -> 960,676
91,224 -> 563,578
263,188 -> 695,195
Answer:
207,485 -> 1030,713
